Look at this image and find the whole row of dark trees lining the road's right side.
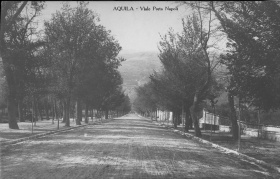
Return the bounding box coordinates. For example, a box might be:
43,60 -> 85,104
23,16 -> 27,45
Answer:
134,1 -> 280,139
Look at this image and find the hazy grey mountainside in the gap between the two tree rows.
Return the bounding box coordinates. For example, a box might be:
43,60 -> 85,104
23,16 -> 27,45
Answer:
119,51 -> 161,102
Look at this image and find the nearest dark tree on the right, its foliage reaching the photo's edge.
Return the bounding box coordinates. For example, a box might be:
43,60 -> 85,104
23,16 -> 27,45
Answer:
209,1 -> 280,139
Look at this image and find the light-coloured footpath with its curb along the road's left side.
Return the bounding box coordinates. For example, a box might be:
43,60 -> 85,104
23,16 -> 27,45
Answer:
0,118 -> 111,148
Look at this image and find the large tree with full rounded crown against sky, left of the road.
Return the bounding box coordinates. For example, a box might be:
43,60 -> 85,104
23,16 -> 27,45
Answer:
45,2 -> 122,126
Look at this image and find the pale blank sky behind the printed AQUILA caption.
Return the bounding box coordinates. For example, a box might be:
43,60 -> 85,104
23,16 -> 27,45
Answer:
41,1 -> 188,53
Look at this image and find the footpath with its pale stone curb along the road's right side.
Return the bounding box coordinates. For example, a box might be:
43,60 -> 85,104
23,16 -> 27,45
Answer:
153,121 -> 280,172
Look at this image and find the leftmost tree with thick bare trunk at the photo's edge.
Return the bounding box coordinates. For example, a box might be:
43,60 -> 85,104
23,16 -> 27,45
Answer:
0,1 -> 43,129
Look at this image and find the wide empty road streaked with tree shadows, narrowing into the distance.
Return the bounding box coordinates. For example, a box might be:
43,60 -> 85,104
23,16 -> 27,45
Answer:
1,114 -> 279,179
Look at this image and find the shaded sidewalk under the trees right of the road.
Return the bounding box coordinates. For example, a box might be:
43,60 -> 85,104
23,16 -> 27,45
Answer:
155,121 -> 280,168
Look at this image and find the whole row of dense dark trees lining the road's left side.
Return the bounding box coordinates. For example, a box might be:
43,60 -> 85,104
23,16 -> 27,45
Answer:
0,1 -> 130,129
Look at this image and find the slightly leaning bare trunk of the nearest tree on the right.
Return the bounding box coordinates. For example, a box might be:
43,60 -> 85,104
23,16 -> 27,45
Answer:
228,92 -> 238,140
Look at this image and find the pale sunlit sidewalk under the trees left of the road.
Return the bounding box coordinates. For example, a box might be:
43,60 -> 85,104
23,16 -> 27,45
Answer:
0,118 -> 107,145
